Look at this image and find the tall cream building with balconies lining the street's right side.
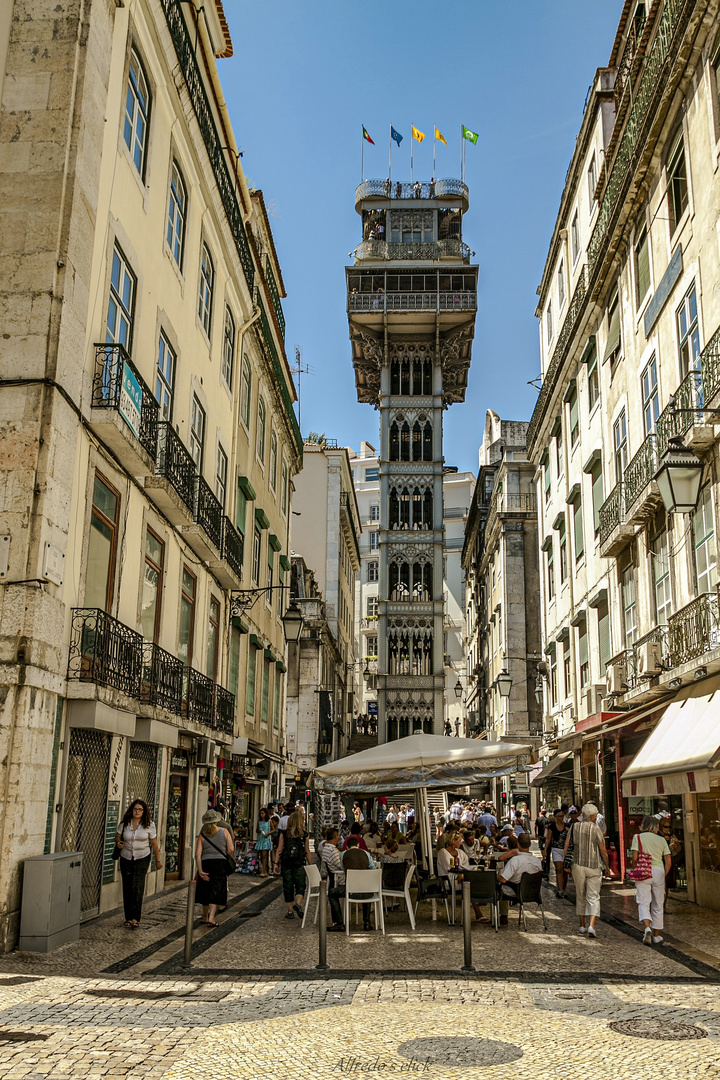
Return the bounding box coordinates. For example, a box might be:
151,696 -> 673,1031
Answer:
528,0 -> 720,906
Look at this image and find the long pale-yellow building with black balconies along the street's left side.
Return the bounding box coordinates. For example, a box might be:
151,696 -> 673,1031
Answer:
0,0 -> 302,948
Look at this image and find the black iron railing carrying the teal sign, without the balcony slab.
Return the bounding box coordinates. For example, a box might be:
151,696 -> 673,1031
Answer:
92,342 -> 159,461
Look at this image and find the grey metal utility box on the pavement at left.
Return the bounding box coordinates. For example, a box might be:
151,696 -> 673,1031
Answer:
17,851 -> 82,953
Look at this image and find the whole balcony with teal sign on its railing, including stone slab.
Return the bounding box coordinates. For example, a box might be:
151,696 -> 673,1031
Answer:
91,342 -> 159,476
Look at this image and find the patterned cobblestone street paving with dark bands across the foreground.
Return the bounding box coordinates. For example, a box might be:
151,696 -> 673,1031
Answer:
0,876 -> 720,1080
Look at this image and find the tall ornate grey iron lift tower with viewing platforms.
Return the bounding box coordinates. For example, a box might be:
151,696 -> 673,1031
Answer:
345,179 -> 477,742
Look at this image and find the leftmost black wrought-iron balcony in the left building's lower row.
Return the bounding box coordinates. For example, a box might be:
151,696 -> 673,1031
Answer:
68,608 -> 142,698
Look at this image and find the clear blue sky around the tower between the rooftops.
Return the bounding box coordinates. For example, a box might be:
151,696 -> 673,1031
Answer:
220,0 -> 622,470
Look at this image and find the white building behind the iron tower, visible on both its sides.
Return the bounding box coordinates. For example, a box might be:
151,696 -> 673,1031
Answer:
350,443 -> 475,734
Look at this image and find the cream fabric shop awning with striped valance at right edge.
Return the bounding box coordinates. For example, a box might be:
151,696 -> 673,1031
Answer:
622,688 -> 720,798
